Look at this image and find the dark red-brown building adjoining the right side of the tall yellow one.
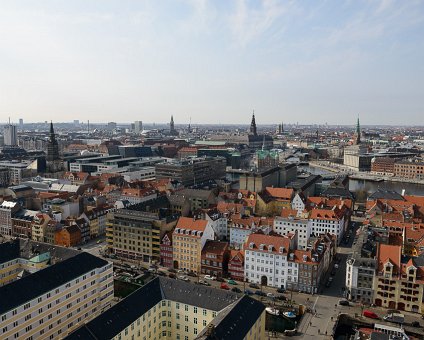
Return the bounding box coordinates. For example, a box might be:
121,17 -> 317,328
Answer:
201,240 -> 230,277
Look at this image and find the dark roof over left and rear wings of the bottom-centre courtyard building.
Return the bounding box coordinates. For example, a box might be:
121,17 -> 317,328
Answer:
66,277 -> 239,340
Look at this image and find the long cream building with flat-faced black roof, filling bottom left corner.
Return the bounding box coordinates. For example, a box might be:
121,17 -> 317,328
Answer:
0,252 -> 113,340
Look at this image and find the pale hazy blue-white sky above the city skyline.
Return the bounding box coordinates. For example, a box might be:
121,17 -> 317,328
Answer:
0,0 -> 424,125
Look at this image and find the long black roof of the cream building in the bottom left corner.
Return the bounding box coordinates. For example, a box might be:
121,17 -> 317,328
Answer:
0,252 -> 107,314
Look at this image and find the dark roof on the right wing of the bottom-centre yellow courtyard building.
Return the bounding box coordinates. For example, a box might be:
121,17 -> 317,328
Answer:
196,295 -> 265,340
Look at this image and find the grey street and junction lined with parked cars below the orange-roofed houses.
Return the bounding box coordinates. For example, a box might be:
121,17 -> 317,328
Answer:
79,229 -> 423,339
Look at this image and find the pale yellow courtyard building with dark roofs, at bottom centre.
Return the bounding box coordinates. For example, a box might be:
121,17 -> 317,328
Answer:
67,277 -> 265,340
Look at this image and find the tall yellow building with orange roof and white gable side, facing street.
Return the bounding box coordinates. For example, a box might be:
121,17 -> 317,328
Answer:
172,217 -> 215,273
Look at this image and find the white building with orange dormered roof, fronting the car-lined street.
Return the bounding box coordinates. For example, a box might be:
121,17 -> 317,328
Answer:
244,234 -> 298,288
